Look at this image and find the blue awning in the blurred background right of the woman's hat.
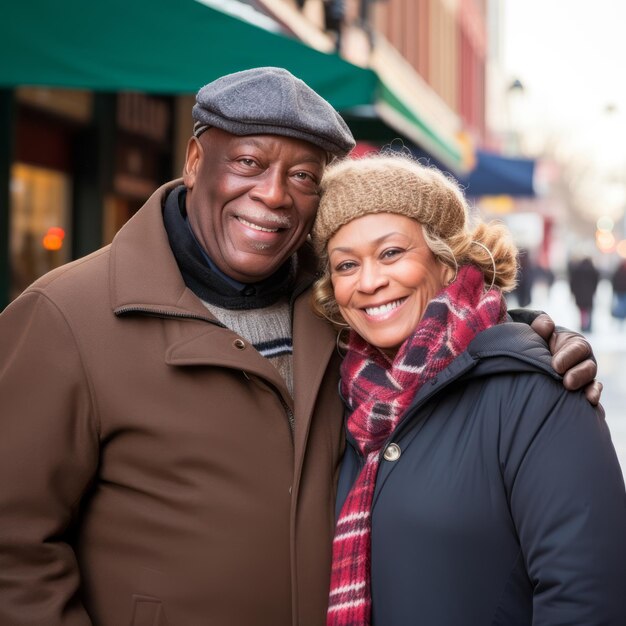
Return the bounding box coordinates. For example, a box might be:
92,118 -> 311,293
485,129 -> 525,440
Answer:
459,150 -> 536,198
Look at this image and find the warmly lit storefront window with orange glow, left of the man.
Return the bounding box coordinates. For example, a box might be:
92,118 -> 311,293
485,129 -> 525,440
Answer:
10,163 -> 71,298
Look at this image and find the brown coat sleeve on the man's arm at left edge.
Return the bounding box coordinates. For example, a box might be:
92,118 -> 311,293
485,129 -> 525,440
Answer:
0,293 -> 98,626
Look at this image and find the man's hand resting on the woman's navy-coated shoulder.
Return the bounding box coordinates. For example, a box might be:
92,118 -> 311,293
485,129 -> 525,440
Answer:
530,313 -> 604,413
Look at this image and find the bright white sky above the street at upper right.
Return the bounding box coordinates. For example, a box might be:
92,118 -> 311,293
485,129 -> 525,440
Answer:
503,0 -> 626,168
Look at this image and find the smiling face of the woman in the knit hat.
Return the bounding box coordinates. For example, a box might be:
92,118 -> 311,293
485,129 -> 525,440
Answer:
328,213 -> 448,354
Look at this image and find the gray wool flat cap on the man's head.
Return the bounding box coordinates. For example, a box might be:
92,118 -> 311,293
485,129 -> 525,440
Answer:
192,67 -> 355,156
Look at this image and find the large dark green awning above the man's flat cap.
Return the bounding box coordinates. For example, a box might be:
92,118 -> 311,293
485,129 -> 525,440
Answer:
0,0 -> 377,110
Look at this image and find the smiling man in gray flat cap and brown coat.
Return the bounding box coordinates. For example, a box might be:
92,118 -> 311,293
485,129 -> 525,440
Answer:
0,68 -> 598,626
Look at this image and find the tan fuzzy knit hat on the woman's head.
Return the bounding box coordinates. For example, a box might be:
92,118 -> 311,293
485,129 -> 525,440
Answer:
312,154 -> 468,254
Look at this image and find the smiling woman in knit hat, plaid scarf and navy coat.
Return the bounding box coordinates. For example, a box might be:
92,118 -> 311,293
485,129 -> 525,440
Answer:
313,155 -> 626,626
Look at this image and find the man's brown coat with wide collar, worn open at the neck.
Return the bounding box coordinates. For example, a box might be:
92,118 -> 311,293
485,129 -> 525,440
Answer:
0,181 -> 342,626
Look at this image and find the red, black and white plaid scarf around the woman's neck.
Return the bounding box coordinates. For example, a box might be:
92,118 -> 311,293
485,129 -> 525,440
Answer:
327,266 -> 506,626
